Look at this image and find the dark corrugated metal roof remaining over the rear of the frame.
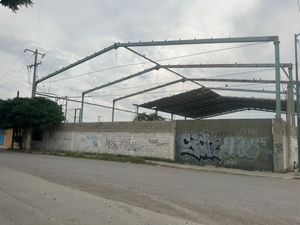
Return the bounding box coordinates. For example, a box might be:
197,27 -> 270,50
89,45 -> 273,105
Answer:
139,87 -> 286,119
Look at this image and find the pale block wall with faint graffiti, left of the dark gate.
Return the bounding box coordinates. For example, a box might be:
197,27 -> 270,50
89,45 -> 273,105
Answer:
32,122 -> 175,160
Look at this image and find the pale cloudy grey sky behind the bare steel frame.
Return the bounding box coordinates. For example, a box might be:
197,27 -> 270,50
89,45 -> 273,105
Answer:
0,0 -> 300,122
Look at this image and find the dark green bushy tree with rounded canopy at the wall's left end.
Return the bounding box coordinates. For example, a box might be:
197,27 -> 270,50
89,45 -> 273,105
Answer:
0,97 -> 64,149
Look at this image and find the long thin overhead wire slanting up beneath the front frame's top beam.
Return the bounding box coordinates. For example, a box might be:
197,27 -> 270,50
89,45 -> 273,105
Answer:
42,42 -> 263,83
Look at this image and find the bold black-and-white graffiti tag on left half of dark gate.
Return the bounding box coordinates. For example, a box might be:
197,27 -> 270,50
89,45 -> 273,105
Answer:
179,131 -> 221,161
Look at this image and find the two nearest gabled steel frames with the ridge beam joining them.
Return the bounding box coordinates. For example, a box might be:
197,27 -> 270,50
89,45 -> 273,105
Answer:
33,36 -> 286,122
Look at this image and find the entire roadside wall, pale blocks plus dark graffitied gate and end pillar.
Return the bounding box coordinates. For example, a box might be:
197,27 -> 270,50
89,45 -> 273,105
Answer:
32,119 -> 298,172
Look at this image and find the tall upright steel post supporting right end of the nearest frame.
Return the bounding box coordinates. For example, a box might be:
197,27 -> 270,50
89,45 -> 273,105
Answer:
274,40 -> 281,118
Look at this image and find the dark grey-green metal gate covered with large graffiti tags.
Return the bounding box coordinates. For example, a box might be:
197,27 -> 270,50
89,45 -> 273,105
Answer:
176,119 -> 273,170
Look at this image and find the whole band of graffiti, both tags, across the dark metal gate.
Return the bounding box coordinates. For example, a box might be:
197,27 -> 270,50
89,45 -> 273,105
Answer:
179,131 -> 271,165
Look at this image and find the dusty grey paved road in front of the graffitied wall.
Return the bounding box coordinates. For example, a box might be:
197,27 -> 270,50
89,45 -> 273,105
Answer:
0,151 -> 300,225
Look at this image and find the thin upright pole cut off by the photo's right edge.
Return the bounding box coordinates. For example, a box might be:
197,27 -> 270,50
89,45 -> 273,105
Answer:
295,33 -> 300,171
